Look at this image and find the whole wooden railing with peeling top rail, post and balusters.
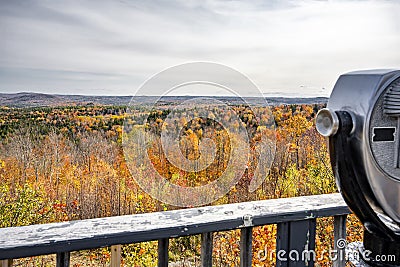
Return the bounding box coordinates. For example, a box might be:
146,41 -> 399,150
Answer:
0,194 -> 350,267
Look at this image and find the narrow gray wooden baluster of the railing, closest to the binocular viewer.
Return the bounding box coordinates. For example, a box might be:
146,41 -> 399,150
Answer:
333,215 -> 347,267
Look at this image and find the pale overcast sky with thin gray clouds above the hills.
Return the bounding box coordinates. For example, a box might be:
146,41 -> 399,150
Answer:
0,0 -> 400,96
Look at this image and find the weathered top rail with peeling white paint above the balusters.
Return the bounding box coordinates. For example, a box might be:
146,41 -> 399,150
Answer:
0,194 -> 350,259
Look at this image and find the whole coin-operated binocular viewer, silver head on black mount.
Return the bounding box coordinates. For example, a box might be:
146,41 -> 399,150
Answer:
316,70 -> 400,266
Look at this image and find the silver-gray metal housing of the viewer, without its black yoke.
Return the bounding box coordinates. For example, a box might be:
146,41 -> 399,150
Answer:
328,70 -> 400,230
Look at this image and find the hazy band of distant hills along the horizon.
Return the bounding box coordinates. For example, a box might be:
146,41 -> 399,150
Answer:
0,92 -> 328,108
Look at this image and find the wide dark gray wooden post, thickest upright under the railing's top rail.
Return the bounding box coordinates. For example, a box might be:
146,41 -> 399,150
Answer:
276,219 -> 316,267
